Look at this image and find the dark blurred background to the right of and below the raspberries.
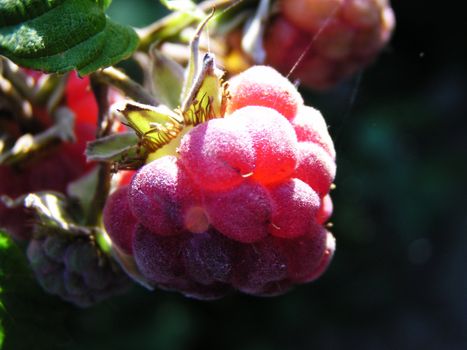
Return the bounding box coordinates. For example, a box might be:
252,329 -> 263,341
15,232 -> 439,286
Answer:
1,0 -> 467,350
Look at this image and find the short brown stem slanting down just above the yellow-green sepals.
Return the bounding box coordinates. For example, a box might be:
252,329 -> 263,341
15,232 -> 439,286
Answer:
92,67 -> 159,106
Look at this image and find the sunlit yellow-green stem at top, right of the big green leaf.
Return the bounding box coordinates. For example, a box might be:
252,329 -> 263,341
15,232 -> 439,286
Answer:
136,0 -> 238,51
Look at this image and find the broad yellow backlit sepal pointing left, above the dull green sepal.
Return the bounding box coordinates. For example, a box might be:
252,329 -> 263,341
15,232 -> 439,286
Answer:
116,102 -> 183,152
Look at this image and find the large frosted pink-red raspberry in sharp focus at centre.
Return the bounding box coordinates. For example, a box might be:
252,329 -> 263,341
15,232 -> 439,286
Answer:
104,66 -> 336,299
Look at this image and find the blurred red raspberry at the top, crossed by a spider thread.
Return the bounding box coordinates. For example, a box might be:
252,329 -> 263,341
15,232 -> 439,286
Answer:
265,0 -> 395,89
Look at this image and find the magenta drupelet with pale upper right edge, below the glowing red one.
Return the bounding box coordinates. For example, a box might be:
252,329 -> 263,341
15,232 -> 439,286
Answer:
269,179 -> 320,238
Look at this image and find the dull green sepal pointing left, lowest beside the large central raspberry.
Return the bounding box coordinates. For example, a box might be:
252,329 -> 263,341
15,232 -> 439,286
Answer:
86,132 -> 138,162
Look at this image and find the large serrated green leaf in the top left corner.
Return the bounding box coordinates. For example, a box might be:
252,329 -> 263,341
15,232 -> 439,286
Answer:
0,0 -> 138,75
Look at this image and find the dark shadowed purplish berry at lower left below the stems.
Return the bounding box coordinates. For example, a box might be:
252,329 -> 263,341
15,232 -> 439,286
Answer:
27,232 -> 129,307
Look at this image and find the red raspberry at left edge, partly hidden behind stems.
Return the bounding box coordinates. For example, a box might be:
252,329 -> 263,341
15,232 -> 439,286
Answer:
0,71 -> 97,239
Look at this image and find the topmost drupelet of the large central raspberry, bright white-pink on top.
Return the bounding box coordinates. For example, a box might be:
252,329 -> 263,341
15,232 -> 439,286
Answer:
226,66 -> 303,120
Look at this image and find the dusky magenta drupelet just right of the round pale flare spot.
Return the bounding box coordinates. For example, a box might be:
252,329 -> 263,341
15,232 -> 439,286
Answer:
205,181 -> 273,243
